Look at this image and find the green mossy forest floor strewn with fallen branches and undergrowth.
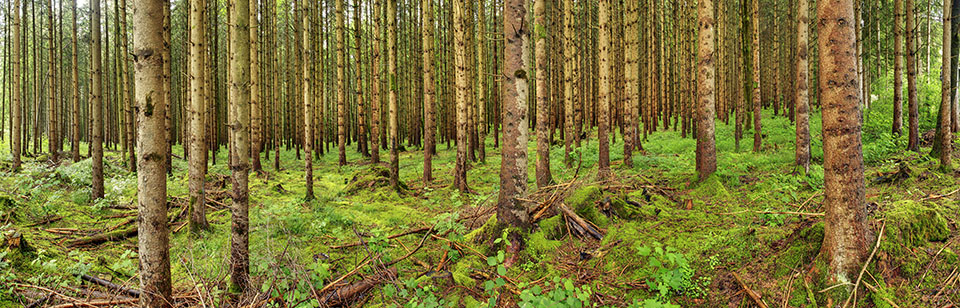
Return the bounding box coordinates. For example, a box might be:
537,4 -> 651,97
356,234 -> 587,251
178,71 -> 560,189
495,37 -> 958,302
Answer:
0,97 -> 960,307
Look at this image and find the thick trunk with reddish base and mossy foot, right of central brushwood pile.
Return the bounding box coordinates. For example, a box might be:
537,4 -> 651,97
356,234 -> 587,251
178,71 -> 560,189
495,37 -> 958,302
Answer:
697,0 -> 717,181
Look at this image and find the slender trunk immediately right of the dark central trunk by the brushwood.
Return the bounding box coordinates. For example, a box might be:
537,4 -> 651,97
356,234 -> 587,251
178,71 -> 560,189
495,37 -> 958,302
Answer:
533,0 -> 553,188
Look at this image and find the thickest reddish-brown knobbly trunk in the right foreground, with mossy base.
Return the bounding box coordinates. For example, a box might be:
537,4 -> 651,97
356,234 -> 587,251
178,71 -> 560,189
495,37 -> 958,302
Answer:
817,0 -> 869,283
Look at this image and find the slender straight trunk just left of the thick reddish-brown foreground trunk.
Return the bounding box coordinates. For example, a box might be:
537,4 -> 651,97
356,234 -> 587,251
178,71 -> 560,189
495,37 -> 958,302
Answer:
794,0 -> 810,174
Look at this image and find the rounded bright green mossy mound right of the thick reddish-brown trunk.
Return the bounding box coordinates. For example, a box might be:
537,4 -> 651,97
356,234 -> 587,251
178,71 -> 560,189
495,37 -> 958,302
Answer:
885,200 -> 950,247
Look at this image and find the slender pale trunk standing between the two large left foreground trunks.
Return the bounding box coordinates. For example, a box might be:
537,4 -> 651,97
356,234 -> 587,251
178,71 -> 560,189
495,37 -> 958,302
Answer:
188,0 -> 209,234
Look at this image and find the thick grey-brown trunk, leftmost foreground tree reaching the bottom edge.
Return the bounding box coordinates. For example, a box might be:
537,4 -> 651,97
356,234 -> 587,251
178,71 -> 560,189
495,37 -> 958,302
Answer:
132,0 -> 173,307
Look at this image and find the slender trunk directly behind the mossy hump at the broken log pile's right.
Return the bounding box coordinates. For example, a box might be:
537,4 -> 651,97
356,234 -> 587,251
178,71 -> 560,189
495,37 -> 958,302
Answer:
597,0 -> 613,179
